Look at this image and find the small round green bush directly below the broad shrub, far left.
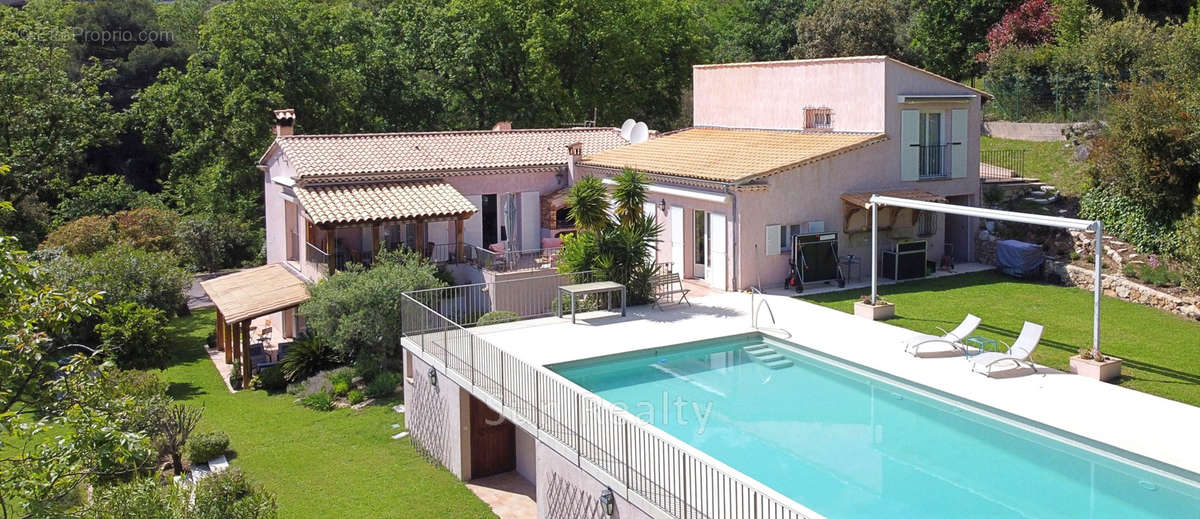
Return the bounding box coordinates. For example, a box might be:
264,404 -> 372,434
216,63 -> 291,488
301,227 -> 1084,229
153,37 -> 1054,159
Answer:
96,302 -> 167,369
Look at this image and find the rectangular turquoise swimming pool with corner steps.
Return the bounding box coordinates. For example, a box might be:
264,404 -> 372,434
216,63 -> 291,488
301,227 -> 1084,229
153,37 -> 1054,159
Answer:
547,334 -> 1200,519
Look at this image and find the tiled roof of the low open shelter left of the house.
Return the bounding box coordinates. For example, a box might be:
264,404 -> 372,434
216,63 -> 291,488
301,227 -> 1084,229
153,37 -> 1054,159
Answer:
200,263 -> 308,324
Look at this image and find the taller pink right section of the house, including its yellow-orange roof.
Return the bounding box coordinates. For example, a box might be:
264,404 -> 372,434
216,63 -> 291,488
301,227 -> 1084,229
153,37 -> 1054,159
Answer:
576,56 -> 986,290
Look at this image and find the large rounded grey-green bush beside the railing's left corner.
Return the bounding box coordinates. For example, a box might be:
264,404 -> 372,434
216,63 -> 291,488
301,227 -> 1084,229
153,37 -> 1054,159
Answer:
300,250 -> 444,370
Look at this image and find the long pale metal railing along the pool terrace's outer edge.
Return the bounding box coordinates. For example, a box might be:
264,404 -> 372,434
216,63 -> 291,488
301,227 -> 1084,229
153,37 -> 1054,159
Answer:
401,287 -> 808,519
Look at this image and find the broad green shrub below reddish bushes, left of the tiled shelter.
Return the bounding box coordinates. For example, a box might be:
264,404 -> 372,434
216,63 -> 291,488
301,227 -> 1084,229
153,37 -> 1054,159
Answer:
43,244 -> 192,315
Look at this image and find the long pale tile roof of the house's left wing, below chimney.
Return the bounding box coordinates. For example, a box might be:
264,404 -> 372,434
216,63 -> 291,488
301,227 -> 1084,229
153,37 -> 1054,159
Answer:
273,127 -> 628,178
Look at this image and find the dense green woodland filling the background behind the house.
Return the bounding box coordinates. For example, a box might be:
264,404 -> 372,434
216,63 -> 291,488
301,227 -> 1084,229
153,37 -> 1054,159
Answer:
0,0 -> 1200,279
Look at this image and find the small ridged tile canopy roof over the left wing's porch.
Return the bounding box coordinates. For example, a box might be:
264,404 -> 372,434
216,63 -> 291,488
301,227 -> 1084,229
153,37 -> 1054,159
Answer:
295,181 -> 476,225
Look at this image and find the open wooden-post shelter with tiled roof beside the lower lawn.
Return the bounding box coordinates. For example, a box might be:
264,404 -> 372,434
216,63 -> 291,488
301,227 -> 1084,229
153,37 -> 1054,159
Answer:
200,263 -> 308,383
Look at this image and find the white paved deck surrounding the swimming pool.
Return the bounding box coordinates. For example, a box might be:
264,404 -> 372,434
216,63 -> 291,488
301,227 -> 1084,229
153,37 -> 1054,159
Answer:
473,293 -> 1200,480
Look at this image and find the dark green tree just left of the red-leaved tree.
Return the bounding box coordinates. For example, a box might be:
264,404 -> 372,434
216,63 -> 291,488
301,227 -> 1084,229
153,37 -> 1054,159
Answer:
908,0 -> 1014,79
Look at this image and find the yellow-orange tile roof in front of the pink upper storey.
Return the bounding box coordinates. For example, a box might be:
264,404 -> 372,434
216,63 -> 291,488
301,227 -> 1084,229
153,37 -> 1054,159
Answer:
582,127 -> 887,184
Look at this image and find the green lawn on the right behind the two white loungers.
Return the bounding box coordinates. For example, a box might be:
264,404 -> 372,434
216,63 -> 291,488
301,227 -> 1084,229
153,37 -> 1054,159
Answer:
803,272 -> 1200,406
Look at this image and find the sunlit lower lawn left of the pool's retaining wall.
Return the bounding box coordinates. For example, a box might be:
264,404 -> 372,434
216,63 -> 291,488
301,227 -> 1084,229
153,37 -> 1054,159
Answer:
162,310 -> 494,518
